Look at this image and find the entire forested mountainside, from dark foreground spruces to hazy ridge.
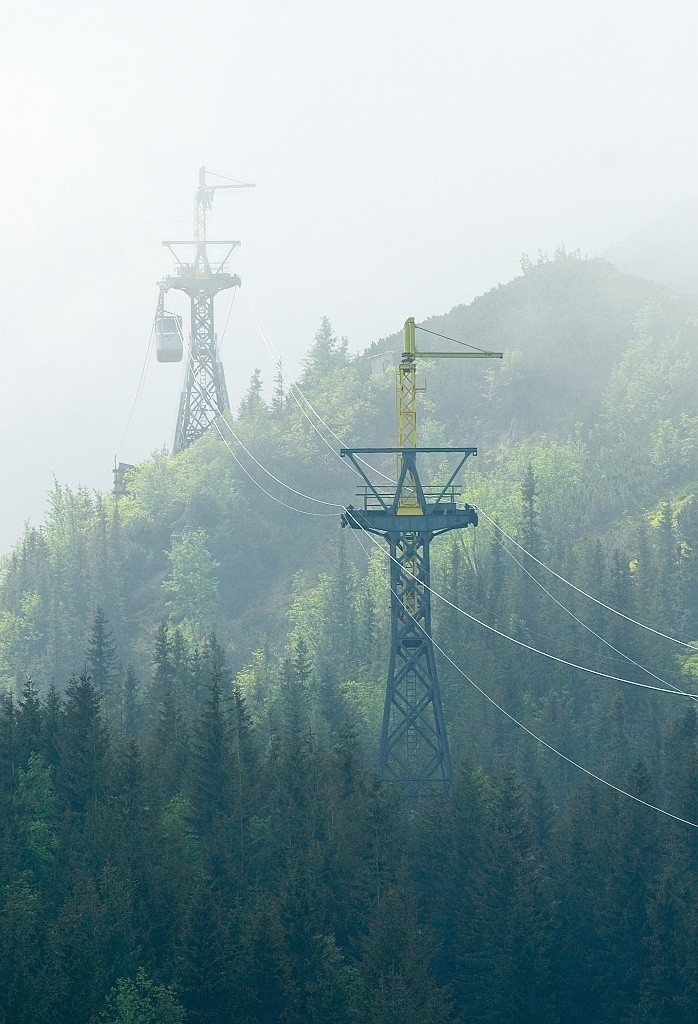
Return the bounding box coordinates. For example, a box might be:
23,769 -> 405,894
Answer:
0,252 -> 698,1024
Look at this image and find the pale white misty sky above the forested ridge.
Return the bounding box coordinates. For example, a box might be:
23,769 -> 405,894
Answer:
0,0 -> 698,551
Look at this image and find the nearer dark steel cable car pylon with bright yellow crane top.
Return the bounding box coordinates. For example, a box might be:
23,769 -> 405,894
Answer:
340,316 -> 503,798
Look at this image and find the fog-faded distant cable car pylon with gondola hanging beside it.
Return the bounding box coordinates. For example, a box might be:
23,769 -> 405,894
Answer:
156,167 -> 254,452
